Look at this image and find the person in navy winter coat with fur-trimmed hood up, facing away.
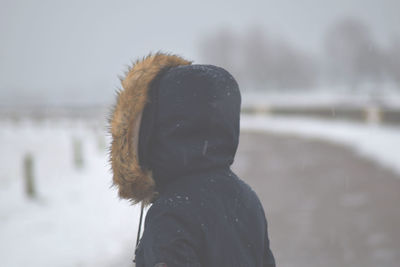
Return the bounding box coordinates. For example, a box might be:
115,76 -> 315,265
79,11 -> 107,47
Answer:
110,53 -> 275,267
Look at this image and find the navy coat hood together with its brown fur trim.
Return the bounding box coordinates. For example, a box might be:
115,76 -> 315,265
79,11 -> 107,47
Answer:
110,54 -> 241,203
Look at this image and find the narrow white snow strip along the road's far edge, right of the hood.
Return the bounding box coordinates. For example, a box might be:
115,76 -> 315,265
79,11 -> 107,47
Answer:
241,115 -> 400,176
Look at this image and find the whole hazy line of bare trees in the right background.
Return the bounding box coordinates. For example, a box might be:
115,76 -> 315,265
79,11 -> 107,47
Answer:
200,18 -> 400,90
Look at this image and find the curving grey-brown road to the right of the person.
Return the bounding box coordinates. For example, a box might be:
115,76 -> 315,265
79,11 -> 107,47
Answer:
233,132 -> 400,267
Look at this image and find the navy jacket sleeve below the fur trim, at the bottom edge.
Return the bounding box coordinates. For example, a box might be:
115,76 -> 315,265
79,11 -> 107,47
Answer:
136,211 -> 201,267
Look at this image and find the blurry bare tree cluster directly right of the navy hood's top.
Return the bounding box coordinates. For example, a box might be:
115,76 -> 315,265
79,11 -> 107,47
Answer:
200,26 -> 316,90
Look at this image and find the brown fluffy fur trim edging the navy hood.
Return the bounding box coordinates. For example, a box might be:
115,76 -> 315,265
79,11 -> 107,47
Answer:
110,53 -> 191,204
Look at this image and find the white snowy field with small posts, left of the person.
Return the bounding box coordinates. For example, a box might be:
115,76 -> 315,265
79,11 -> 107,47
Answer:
0,120 -> 138,267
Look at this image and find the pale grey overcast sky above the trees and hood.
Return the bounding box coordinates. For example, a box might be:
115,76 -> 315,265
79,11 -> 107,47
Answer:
0,0 -> 400,105
